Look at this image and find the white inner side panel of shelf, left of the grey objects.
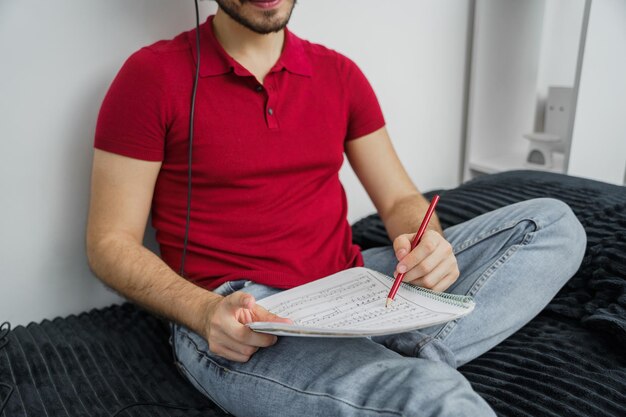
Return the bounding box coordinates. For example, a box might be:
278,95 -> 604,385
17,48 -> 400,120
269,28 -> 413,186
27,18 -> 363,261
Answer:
466,0 -> 545,167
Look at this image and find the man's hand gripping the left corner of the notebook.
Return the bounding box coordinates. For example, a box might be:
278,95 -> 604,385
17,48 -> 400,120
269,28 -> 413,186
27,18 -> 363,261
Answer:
205,291 -> 292,362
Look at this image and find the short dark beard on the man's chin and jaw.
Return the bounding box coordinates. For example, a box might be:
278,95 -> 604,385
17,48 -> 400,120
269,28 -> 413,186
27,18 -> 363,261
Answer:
215,0 -> 297,35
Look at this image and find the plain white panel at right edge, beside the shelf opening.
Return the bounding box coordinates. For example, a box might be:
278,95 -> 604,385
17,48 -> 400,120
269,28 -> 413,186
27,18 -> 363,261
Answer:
567,0 -> 626,185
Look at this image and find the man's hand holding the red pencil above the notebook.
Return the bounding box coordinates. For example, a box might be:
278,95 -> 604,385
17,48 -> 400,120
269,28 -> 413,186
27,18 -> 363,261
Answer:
393,230 -> 459,291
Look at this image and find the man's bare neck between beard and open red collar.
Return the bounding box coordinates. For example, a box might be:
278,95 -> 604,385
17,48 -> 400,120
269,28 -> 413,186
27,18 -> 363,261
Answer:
213,8 -> 285,83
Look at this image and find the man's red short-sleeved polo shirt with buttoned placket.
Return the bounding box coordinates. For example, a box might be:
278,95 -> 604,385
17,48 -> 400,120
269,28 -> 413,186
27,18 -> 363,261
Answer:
95,17 -> 384,289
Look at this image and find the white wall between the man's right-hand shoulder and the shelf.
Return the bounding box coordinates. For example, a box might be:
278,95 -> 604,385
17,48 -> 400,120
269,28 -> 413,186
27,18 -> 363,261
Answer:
290,0 -> 469,221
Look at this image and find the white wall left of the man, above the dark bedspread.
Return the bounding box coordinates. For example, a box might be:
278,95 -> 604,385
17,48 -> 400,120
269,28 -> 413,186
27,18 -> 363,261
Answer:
0,0 -> 216,325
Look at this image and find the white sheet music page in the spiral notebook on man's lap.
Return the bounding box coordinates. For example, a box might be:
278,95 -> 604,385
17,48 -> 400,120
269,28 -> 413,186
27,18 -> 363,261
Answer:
251,268 -> 466,334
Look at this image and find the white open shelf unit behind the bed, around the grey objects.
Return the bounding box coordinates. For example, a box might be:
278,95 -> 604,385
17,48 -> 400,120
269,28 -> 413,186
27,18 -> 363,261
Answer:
463,0 -> 588,181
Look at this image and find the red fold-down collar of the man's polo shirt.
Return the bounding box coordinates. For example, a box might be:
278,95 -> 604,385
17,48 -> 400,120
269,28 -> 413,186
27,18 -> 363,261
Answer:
187,16 -> 312,77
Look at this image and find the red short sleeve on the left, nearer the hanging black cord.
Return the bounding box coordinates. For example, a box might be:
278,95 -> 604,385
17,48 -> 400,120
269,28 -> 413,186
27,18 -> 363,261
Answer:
94,48 -> 167,161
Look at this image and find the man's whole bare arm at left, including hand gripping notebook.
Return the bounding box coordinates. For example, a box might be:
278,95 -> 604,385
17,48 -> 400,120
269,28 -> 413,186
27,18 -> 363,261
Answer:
87,150 -> 286,362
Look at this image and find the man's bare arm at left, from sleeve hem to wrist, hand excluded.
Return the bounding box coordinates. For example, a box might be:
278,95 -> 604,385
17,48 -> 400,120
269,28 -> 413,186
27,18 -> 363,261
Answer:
87,150 -> 219,333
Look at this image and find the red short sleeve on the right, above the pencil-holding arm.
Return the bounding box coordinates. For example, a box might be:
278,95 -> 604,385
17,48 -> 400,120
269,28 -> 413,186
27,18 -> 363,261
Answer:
346,58 -> 385,141
